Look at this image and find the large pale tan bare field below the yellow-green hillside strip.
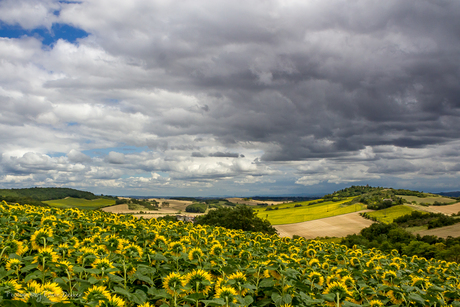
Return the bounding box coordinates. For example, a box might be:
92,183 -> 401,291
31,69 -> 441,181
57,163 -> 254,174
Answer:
274,210 -> 374,239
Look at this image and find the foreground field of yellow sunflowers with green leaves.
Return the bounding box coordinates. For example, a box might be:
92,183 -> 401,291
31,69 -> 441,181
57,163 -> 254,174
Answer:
0,202 -> 460,307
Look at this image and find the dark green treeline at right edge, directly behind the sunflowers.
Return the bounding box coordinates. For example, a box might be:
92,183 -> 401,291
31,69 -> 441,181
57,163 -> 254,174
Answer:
341,223 -> 460,262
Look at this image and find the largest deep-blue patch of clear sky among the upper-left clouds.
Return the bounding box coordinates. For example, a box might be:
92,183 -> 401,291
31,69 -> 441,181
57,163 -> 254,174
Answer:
0,21 -> 89,46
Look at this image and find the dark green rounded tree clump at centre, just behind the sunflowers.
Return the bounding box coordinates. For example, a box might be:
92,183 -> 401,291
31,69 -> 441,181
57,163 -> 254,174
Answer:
195,205 -> 277,234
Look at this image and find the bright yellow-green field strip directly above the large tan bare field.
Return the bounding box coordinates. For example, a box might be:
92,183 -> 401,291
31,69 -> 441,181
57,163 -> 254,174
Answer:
254,197 -> 365,225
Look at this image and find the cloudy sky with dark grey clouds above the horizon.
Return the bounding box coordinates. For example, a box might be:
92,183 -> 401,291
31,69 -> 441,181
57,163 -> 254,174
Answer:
0,0 -> 460,196
